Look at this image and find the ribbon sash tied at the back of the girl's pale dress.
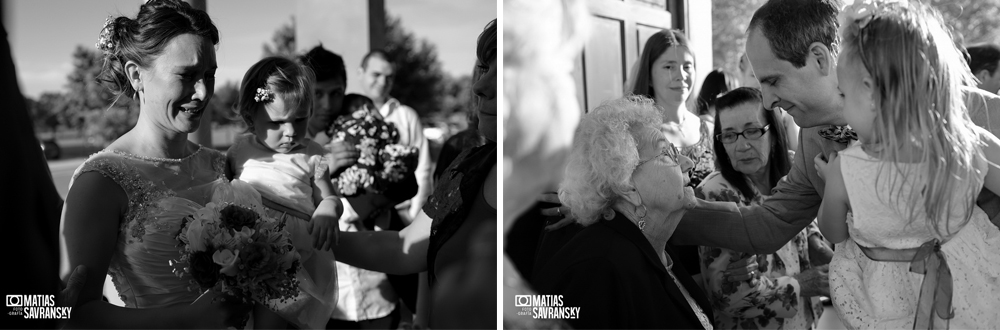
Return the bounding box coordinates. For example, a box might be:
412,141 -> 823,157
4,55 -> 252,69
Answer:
858,239 -> 955,329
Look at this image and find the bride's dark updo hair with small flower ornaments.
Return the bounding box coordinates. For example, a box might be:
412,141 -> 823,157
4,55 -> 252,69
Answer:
97,0 -> 219,98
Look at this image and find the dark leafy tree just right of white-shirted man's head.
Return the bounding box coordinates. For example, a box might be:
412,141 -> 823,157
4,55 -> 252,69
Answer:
385,13 -> 447,118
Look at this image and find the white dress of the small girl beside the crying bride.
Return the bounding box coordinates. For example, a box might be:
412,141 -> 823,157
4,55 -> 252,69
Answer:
226,134 -> 337,329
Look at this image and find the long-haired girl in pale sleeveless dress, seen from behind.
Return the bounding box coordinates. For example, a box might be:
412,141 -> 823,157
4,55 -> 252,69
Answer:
816,0 -> 1000,329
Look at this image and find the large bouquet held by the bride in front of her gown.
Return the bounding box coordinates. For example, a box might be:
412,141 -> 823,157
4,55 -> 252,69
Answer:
170,198 -> 299,309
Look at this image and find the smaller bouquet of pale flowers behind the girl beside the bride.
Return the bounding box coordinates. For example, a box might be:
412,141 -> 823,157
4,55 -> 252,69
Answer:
333,108 -> 418,197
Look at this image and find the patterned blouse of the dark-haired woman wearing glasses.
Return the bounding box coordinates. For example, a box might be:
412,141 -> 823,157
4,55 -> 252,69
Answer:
695,172 -> 823,329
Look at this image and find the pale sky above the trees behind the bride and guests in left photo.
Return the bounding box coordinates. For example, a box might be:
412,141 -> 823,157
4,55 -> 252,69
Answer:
3,0 -> 497,98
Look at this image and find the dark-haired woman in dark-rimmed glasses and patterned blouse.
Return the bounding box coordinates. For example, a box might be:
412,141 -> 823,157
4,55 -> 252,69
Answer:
695,87 -> 828,329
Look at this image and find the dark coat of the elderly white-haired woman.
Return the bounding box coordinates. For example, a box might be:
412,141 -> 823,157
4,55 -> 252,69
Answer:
533,214 -> 713,329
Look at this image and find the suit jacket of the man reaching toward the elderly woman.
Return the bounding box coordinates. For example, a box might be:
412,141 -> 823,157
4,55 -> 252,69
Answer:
674,88 -> 1000,253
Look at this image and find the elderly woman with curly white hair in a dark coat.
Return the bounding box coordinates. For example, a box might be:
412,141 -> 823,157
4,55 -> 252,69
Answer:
533,96 -> 712,329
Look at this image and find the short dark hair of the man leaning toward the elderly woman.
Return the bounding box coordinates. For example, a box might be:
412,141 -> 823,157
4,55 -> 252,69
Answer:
747,0 -> 843,68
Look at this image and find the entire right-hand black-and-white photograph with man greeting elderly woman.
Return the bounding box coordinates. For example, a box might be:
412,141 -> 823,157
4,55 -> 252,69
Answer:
500,0 -> 1000,329
